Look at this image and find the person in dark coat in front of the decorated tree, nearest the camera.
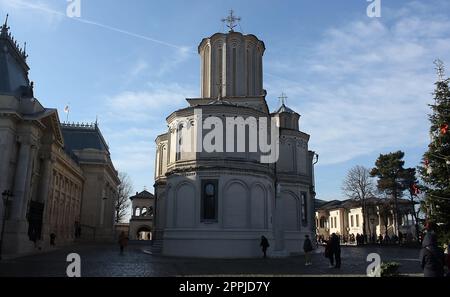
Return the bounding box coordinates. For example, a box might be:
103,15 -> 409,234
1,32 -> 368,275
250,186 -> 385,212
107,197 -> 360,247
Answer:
420,232 -> 445,277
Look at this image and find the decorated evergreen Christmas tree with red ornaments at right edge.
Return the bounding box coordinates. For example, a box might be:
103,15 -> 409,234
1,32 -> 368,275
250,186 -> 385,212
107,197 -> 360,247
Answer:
419,60 -> 450,241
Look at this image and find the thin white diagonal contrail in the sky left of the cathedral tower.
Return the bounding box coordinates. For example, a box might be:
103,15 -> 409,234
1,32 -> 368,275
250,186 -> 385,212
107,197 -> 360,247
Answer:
8,0 -> 189,51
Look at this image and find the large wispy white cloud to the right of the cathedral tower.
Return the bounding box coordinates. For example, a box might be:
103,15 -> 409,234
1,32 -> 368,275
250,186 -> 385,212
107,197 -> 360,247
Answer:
266,2 -> 450,165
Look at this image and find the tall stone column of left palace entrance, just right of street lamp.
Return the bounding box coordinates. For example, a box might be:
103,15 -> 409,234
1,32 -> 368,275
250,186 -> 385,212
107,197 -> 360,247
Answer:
11,141 -> 32,220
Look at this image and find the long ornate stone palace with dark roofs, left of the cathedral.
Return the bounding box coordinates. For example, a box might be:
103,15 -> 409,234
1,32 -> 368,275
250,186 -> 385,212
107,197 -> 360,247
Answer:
0,17 -> 119,255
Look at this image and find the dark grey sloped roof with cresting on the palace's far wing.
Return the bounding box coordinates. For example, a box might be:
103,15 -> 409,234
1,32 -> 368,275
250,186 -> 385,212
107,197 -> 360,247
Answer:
61,124 -> 109,152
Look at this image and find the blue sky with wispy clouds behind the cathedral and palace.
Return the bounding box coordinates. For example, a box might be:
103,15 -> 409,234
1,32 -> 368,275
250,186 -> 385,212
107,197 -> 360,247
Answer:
0,0 -> 450,200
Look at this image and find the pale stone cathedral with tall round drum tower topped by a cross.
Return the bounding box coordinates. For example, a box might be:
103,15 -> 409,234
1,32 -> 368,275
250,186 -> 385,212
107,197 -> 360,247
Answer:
154,14 -> 317,258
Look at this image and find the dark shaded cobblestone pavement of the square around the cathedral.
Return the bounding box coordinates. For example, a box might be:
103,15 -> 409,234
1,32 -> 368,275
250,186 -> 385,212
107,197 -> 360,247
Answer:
0,243 -> 422,277
